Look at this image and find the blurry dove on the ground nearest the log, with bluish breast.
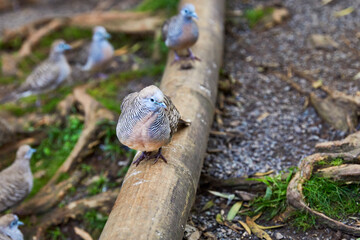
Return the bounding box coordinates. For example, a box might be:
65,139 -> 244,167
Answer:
82,26 -> 114,71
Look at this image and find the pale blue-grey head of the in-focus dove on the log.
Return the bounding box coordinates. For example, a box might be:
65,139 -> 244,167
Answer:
139,85 -> 167,112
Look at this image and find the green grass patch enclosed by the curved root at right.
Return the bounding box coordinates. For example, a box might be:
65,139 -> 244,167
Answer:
303,176 -> 360,220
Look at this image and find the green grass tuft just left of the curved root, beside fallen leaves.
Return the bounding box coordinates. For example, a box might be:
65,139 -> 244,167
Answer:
251,168 -> 295,219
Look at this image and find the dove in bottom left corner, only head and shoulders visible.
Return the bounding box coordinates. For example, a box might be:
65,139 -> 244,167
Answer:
0,214 -> 24,240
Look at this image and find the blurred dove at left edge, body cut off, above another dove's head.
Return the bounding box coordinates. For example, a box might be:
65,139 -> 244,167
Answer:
0,145 -> 35,212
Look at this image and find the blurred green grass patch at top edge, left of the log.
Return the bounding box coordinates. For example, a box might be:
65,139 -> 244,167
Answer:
136,0 -> 179,15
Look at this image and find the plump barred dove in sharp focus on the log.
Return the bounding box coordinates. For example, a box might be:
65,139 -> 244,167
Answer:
116,85 -> 189,166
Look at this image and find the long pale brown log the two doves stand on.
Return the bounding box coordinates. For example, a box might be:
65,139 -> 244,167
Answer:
100,0 -> 225,240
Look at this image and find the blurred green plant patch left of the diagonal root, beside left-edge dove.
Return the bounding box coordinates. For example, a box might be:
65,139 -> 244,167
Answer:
28,116 -> 84,198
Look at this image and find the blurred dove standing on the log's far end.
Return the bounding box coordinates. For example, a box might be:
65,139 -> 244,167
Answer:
162,4 -> 200,64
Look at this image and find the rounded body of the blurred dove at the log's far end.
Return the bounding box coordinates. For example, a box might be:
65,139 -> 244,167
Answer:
162,14 -> 199,50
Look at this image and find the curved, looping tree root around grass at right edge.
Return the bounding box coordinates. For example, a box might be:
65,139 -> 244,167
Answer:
287,132 -> 360,236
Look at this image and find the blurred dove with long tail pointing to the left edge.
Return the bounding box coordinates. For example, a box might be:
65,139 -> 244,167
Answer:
0,40 -> 71,104
